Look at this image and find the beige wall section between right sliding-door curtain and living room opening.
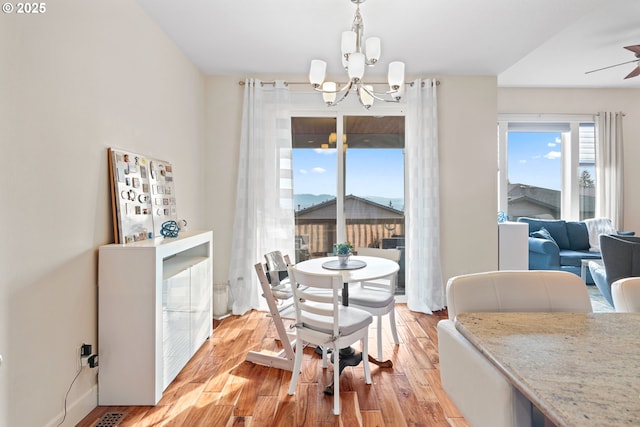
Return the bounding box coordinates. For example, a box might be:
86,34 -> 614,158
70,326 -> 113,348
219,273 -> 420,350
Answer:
438,77 -> 498,282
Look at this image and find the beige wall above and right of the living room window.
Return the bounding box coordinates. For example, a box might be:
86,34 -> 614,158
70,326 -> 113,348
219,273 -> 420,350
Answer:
498,88 -> 640,234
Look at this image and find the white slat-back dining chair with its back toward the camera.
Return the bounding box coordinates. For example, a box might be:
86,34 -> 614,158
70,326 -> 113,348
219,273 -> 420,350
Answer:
289,266 -> 373,415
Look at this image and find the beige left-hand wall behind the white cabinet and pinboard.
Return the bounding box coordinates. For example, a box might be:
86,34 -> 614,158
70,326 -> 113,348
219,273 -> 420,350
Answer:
0,0 -> 205,427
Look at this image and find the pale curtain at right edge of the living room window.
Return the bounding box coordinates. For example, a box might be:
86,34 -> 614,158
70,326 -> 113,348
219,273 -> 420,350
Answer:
596,112 -> 624,230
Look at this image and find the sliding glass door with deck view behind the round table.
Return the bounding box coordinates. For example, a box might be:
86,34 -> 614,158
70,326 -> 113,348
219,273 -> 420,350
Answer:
291,114 -> 405,293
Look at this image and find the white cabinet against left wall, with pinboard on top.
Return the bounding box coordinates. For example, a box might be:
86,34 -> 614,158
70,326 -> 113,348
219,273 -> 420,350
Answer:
98,231 -> 213,406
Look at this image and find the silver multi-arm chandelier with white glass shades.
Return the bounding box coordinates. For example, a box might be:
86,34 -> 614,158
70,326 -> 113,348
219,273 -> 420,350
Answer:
309,0 -> 404,109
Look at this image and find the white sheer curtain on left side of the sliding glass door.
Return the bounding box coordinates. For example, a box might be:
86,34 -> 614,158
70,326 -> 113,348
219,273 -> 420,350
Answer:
229,79 -> 295,314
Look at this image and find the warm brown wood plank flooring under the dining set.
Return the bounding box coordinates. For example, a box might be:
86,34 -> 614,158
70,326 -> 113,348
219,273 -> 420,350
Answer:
78,304 -> 469,427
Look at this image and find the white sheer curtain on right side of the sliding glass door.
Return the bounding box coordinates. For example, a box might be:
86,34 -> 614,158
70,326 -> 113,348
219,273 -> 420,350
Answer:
405,79 -> 446,314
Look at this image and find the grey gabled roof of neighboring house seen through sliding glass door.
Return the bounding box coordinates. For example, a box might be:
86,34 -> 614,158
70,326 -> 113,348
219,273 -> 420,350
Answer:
295,194 -> 404,221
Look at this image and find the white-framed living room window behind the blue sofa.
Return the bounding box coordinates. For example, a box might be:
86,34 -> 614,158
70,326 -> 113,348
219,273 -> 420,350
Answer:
498,115 -> 595,221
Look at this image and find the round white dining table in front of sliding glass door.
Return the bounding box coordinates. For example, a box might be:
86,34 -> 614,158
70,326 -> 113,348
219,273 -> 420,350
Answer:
296,255 -> 400,306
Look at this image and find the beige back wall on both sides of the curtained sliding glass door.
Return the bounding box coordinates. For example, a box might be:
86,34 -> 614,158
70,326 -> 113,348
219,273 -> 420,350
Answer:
207,76 -> 498,298
